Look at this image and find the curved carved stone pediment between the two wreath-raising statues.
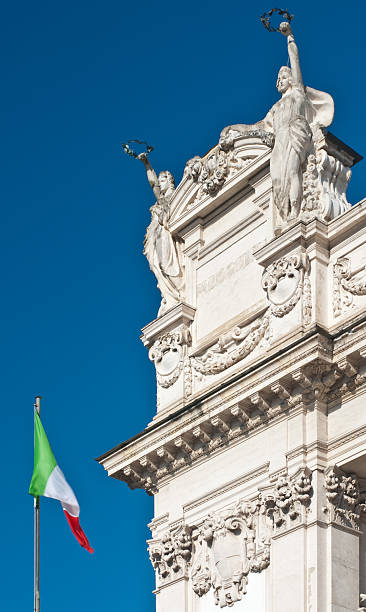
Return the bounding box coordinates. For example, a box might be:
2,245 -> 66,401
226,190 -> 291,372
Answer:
170,135 -> 271,232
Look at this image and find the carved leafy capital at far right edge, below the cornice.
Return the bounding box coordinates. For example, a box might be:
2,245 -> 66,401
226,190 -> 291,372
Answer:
324,466 -> 366,530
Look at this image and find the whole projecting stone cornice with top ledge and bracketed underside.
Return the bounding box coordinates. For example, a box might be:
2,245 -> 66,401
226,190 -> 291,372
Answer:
98,323 -> 366,494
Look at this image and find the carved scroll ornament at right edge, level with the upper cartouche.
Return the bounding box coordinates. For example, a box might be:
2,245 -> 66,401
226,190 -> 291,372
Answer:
333,257 -> 366,317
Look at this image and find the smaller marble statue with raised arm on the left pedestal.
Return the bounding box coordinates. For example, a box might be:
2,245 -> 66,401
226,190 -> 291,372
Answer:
137,153 -> 184,316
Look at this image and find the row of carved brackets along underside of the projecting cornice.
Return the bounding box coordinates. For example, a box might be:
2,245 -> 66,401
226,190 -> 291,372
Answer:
107,350 -> 366,494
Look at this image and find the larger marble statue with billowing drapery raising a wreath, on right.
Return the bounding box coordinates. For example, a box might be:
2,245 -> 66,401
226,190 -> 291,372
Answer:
220,22 -> 334,231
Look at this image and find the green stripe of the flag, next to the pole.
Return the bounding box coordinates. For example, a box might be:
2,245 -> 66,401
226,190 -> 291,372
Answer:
29,411 -> 57,497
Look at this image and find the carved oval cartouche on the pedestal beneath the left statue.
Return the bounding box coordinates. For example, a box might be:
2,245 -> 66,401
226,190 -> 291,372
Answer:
149,327 -> 191,388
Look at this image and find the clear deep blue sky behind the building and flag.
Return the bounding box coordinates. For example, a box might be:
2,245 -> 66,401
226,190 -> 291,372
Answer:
0,0 -> 366,612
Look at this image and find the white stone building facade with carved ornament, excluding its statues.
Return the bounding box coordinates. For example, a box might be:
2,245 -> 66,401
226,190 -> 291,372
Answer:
98,122 -> 366,612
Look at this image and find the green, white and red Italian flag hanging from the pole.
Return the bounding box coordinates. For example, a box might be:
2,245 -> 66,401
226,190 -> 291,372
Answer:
29,410 -> 94,553
